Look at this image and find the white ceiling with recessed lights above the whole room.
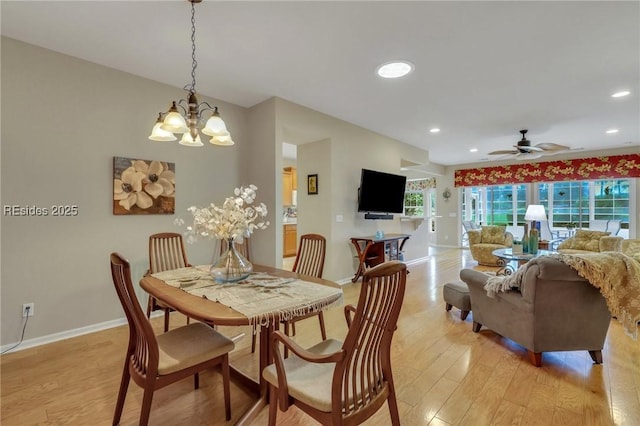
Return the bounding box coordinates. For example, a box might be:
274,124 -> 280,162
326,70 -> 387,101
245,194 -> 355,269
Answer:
0,0 -> 640,165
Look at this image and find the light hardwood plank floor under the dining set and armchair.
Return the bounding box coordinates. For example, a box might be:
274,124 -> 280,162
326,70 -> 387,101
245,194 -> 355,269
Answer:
0,249 -> 640,426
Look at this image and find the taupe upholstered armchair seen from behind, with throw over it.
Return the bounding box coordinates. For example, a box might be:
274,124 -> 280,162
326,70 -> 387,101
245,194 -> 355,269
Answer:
460,256 -> 611,367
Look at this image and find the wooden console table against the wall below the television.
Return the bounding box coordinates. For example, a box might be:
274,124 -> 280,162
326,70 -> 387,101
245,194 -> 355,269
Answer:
351,234 -> 410,282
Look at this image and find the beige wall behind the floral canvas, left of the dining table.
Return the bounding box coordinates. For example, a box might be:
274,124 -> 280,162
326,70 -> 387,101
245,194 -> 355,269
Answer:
1,38 -> 250,345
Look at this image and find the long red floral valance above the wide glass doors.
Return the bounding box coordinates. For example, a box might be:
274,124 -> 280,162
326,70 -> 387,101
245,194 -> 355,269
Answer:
455,154 -> 640,186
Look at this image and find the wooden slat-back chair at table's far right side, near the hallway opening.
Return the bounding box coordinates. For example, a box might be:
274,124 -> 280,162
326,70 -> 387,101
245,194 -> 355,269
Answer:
282,234 -> 327,340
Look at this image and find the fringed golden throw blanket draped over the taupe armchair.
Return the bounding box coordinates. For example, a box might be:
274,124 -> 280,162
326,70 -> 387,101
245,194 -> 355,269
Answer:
484,252 -> 640,339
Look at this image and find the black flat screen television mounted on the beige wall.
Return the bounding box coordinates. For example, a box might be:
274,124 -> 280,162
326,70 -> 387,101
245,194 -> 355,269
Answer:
358,169 -> 407,219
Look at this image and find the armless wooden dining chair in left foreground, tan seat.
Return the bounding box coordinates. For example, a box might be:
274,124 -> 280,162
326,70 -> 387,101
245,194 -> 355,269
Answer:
111,253 -> 235,425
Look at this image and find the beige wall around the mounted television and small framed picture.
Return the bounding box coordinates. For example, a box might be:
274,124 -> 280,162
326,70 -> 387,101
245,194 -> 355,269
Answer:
276,99 -> 438,281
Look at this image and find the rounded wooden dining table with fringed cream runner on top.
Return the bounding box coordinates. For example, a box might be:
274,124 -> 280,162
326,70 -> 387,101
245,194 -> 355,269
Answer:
140,264 -> 343,425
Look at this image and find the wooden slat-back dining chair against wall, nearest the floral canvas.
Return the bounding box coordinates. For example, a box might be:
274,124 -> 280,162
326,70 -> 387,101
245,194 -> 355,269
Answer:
147,232 -> 191,331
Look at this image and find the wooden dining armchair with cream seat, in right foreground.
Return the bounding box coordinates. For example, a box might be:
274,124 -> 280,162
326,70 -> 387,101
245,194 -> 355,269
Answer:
262,261 -> 407,426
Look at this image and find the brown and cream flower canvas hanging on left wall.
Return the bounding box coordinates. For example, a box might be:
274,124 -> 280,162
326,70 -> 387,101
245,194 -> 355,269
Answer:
113,157 -> 176,215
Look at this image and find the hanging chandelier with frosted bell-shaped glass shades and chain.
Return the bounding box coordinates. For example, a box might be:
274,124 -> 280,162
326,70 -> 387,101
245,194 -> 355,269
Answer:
149,0 -> 234,146
